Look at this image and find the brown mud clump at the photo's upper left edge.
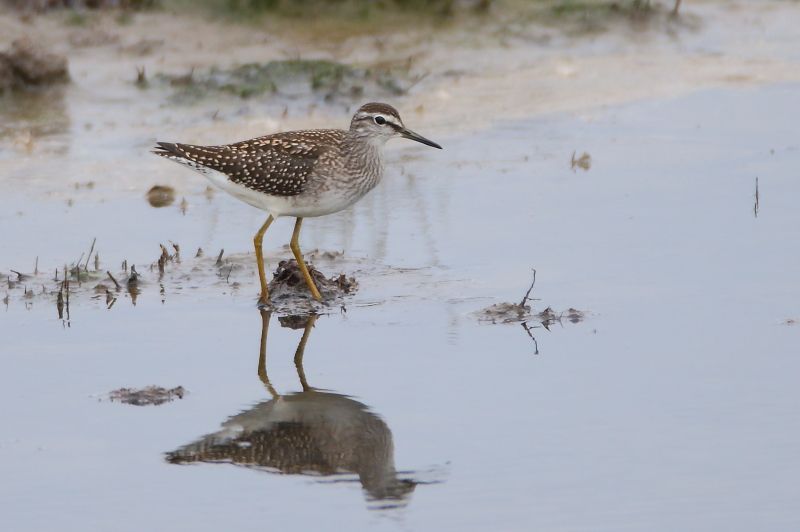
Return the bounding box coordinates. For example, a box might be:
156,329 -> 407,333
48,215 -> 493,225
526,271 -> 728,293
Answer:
0,39 -> 69,91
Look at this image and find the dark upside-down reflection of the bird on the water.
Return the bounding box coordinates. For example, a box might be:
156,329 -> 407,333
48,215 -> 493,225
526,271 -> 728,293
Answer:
167,310 -> 417,507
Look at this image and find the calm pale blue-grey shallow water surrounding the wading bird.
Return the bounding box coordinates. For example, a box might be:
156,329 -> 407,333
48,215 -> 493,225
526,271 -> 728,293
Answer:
0,85 -> 800,530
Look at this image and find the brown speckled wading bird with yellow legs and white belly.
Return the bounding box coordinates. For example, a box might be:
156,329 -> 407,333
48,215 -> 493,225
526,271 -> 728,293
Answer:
153,103 -> 442,305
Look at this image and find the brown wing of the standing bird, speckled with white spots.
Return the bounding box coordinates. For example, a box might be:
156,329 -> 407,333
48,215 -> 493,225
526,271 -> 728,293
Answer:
153,130 -> 344,196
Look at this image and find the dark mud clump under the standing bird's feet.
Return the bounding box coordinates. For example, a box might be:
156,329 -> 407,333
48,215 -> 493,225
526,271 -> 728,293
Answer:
269,260 -> 358,302
